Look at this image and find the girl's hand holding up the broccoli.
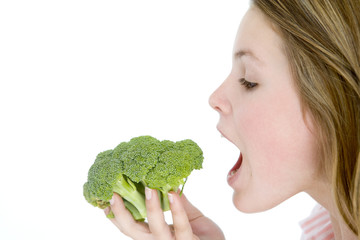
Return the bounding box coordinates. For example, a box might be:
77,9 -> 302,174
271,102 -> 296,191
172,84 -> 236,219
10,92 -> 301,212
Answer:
105,189 -> 225,240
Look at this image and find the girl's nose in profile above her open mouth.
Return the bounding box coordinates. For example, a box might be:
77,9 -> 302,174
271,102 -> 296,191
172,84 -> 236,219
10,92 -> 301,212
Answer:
209,82 -> 231,114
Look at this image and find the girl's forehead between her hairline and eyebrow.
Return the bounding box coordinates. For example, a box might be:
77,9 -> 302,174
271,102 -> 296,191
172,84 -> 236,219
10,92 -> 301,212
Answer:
233,7 -> 283,62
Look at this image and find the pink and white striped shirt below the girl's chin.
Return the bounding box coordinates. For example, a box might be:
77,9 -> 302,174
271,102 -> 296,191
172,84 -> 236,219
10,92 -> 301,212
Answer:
300,205 -> 335,240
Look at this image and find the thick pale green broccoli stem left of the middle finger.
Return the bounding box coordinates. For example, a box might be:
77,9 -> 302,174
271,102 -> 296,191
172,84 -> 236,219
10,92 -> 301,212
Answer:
113,176 -> 146,221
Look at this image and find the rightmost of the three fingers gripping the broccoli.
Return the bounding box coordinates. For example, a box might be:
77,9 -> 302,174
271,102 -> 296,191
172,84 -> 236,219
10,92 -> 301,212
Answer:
168,193 -> 193,240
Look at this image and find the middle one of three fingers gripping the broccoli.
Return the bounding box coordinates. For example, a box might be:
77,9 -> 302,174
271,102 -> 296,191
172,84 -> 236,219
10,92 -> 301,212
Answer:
145,188 -> 172,240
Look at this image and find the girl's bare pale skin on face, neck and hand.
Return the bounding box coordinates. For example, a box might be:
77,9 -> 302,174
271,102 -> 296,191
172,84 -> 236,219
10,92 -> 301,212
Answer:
105,7 -> 356,240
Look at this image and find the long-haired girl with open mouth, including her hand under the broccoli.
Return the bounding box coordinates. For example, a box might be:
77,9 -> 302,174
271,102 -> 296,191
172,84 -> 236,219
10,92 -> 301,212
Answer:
105,0 -> 360,240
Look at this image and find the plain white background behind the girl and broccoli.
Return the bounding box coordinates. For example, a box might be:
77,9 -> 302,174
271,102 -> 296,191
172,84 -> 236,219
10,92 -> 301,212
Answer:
0,0 -> 314,240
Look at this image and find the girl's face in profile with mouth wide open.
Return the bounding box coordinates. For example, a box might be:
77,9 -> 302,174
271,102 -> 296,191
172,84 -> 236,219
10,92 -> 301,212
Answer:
209,7 -> 319,212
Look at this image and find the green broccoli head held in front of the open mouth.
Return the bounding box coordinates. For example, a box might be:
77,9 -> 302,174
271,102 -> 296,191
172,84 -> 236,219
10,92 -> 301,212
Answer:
83,136 -> 204,221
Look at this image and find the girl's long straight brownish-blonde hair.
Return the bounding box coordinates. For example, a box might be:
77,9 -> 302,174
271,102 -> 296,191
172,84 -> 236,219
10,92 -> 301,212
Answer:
252,0 -> 360,236
